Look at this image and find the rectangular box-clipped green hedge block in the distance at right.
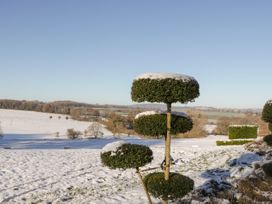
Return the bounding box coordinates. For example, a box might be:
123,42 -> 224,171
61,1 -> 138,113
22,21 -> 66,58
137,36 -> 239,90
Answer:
229,125 -> 258,139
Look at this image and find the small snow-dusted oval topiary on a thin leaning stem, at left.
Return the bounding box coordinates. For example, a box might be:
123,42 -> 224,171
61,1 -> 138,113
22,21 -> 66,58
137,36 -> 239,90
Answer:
100,141 -> 153,204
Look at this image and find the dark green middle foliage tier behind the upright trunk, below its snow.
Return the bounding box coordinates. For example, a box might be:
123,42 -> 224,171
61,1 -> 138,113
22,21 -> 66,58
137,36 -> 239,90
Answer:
134,114 -> 193,137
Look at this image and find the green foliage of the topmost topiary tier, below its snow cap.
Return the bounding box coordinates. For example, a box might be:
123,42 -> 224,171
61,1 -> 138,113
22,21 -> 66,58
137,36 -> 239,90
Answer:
131,79 -> 199,104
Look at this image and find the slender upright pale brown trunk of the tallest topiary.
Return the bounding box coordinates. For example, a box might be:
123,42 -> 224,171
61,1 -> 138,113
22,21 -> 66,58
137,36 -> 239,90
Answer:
164,103 -> 171,204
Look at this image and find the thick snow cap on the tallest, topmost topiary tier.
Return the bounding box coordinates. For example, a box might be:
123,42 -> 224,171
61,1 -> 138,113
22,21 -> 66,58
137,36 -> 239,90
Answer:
134,73 -> 195,81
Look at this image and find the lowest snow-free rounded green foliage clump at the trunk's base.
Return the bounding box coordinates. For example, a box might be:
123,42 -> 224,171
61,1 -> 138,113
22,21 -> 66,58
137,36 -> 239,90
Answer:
144,172 -> 194,200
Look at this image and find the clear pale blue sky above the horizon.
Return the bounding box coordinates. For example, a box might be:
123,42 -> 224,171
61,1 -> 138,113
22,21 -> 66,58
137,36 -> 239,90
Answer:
0,0 -> 272,108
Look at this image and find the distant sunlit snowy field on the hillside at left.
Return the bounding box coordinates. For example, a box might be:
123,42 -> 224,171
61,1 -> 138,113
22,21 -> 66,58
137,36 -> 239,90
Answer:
0,109 -> 111,137
